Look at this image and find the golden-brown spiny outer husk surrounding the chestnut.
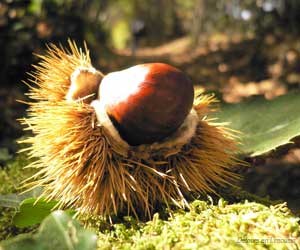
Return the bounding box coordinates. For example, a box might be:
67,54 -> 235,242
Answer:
22,42 -> 238,217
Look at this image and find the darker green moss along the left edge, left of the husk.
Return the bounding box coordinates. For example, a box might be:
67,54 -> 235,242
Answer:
0,154 -> 34,241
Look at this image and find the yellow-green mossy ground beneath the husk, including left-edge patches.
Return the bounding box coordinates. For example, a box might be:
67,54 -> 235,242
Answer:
0,155 -> 300,249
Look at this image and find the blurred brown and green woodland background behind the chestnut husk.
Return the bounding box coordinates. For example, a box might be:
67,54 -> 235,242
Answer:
0,0 -> 300,211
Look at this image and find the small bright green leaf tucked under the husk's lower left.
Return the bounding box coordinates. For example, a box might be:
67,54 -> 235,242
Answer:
13,198 -> 58,227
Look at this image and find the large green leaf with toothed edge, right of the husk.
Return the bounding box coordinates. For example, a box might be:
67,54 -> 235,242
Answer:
217,92 -> 300,156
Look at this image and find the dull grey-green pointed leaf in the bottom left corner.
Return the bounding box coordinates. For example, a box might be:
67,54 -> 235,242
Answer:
0,210 -> 97,250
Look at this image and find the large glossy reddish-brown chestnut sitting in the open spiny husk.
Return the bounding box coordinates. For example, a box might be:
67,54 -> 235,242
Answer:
99,63 -> 194,146
